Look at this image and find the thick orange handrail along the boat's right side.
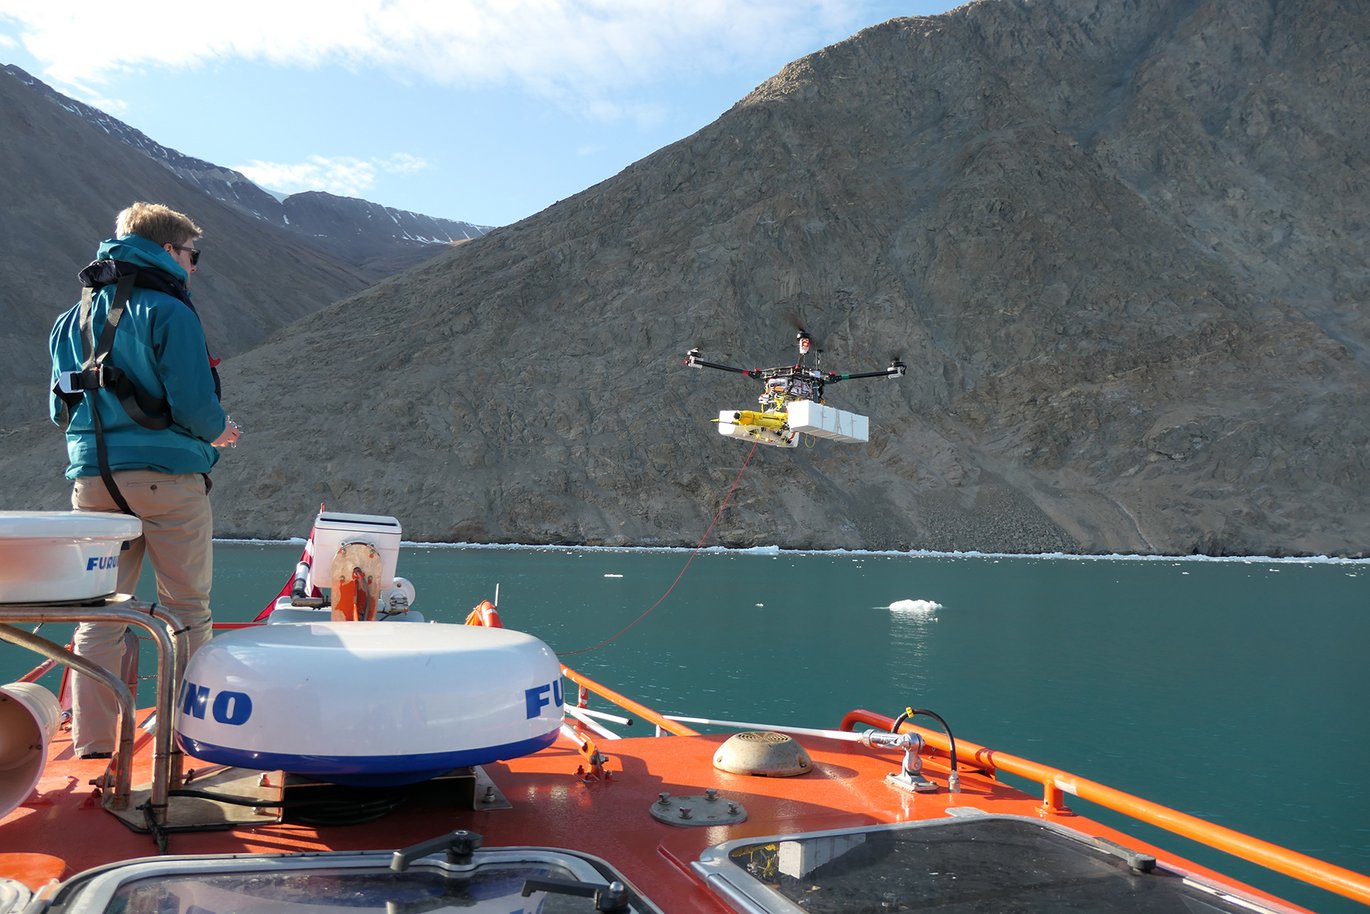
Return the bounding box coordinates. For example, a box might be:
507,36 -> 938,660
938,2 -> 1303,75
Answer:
840,708 -> 1370,904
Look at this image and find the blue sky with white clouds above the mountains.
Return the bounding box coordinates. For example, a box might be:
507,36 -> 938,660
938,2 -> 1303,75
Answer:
0,0 -> 958,225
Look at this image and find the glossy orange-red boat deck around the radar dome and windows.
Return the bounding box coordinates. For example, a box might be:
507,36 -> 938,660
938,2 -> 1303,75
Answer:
0,711 -> 1326,911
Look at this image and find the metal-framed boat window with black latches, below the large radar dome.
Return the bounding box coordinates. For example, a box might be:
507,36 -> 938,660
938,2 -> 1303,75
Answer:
52,848 -> 656,914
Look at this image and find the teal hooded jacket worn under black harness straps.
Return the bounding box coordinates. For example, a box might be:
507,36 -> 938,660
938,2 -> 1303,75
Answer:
48,234 -> 227,480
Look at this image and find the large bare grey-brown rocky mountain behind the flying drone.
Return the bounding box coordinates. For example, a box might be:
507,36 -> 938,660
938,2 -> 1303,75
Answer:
0,0 -> 1370,555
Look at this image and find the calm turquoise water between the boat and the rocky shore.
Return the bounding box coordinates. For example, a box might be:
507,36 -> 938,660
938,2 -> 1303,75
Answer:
0,544 -> 1370,911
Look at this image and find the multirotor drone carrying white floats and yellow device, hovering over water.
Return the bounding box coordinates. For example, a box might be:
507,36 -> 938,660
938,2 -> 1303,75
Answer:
685,330 -> 907,448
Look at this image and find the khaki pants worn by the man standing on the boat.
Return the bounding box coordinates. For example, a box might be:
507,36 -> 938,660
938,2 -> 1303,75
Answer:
71,470 -> 214,755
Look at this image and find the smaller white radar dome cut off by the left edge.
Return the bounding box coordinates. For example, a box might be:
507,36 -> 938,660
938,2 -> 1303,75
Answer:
0,511 -> 142,603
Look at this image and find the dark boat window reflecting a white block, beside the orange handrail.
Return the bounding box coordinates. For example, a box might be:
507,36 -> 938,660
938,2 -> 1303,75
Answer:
695,814 -> 1284,914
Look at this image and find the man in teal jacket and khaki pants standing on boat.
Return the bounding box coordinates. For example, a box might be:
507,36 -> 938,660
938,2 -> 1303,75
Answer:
49,203 -> 240,758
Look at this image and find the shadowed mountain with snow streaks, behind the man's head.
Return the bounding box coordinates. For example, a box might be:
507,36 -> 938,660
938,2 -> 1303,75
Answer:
0,66 -> 484,426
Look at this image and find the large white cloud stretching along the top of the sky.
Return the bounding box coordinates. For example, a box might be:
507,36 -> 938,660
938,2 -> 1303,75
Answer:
0,0 -> 866,121
